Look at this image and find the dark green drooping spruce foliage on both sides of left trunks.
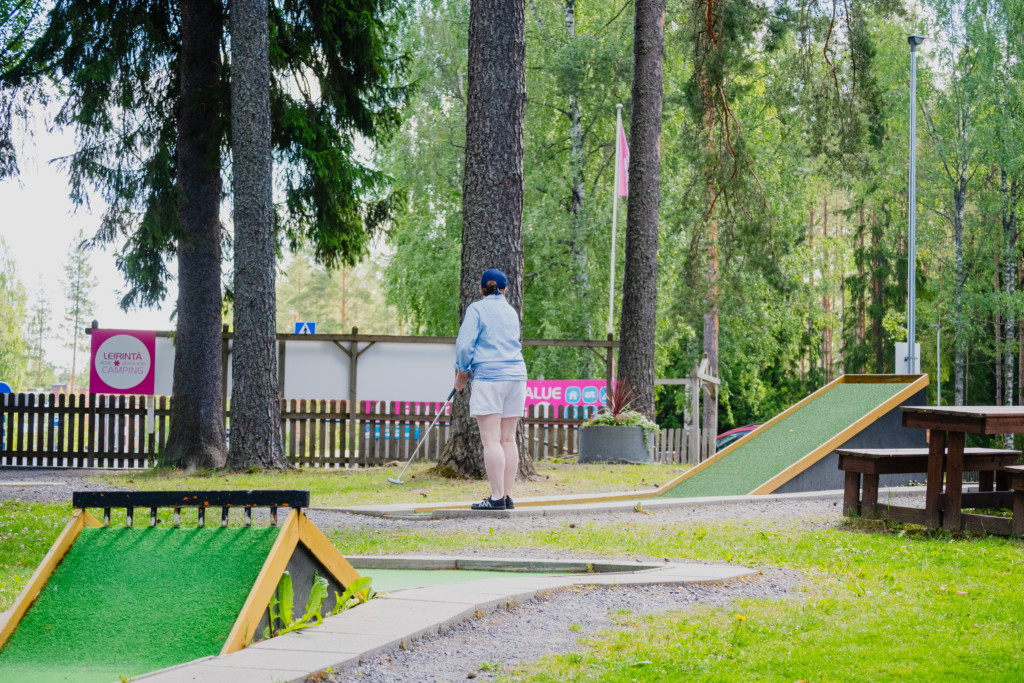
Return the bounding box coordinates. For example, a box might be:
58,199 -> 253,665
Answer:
0,0 -> 408,307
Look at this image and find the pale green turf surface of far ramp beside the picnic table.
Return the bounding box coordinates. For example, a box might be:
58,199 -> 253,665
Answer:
663,383 -> 909,498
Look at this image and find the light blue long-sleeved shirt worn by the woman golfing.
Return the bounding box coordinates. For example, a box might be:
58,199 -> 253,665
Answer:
455,294 -> 526,382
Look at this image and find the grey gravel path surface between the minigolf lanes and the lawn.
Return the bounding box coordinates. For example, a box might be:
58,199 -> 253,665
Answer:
0,469 -> 922,683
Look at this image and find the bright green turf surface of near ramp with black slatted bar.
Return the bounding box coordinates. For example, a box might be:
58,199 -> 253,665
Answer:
0,527 -> 280,683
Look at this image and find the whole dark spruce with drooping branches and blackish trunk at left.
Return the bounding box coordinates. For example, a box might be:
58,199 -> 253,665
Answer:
0,0 -> 406,467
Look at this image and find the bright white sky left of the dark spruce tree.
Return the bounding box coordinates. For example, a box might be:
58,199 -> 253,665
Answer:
0,122 -> 177,367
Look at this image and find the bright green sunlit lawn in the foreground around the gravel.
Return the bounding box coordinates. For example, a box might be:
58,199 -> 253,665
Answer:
0,475 -> 1024,682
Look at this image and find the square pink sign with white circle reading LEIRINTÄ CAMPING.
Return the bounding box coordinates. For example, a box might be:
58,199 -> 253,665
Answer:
89,329 -> 157,394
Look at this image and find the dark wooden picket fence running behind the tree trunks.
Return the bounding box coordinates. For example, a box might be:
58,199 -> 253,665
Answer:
0,393 -> 698,468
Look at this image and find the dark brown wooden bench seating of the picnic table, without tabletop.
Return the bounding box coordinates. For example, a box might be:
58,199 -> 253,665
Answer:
836,449 -> 1024,524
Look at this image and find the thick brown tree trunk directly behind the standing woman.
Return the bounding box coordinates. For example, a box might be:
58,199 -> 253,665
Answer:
437,0 -> 536,479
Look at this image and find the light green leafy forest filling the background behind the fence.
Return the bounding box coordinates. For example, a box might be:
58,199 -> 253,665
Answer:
0,0 -> 1024,436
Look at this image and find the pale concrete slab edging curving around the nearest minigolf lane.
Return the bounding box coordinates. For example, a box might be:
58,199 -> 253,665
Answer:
132,557 -> 757,683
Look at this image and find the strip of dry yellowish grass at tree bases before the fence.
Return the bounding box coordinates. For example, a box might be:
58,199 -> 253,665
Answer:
100,461 -> 688,506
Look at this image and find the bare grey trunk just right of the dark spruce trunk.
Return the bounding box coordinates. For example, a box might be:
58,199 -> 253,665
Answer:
227,0 -> 288,470
